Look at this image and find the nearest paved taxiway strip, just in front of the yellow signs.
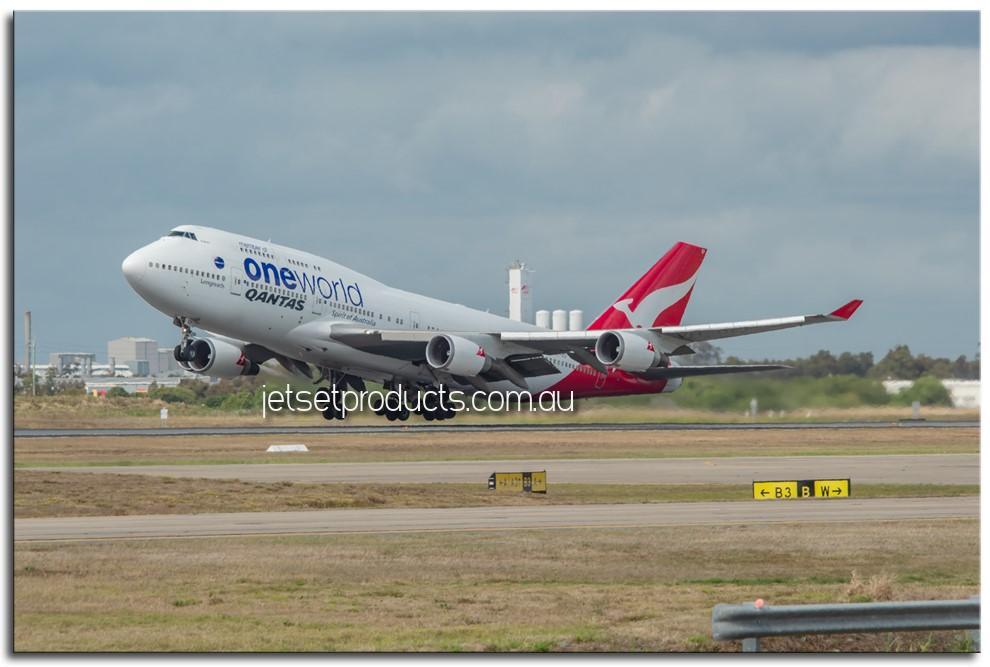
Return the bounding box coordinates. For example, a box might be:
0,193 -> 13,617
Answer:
14,496 -> 980,541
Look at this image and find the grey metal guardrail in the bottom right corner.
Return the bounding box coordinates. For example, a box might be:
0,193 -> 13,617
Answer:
712,597 -> 980,651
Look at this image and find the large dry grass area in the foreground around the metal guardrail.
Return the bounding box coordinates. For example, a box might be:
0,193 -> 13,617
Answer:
13,520 -> 979,651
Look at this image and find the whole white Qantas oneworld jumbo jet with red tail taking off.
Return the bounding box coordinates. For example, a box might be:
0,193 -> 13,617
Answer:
122,225 -> 862,421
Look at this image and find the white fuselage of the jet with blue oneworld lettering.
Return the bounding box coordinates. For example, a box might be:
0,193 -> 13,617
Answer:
123,225 -> 578,391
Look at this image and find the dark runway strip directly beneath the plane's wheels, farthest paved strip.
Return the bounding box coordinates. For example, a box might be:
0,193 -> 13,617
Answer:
14,421 -> 980,438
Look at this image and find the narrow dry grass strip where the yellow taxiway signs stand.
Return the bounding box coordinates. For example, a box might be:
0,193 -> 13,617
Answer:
14,470 -> 979,519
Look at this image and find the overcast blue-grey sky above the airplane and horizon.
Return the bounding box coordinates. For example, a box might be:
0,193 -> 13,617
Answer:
14,12 -> 979,362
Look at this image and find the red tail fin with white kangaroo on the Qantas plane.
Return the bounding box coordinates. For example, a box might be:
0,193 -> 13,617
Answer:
588,242 -> 707,329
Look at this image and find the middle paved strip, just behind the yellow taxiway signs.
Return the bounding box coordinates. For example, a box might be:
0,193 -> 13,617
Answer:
52,454 -> 980,485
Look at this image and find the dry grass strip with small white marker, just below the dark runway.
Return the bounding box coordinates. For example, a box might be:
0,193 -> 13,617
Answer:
14,427 -> 980,467
